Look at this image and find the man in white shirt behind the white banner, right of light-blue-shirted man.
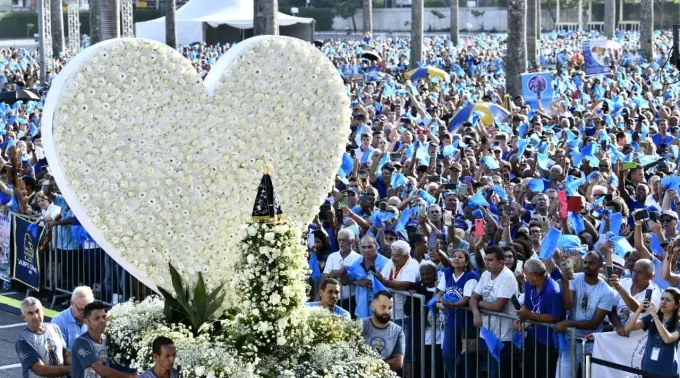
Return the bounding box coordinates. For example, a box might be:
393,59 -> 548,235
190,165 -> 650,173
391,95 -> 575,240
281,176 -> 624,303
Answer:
609,259 -> 662,324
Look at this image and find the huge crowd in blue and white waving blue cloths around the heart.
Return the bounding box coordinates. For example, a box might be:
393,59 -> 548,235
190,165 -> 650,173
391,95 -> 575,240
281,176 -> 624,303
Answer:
6,25 -> 680,378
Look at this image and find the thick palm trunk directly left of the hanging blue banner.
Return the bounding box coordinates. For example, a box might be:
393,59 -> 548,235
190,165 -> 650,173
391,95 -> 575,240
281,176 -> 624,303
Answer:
505,0 -> 527,97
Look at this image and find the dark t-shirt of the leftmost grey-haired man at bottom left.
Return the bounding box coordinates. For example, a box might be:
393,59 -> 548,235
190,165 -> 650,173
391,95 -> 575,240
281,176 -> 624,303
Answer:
15,323 -> 68,378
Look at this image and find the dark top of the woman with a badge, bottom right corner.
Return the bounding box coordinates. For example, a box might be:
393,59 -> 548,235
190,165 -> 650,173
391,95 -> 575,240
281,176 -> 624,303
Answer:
641,316 -> 680,376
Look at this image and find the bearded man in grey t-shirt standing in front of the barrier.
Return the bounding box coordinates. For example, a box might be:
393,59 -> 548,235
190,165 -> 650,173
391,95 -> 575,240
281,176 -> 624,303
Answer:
362,290 -> 406,371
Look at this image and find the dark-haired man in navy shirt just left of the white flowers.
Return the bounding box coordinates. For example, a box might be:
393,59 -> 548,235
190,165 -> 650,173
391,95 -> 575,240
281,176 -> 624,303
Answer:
71,301 -> 138,378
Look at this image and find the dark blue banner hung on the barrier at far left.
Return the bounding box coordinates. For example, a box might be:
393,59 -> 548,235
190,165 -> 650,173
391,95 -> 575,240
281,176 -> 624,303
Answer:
12,214 -> 44,290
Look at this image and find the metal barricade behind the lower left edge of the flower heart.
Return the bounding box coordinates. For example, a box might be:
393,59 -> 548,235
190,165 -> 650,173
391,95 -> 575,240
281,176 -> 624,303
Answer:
43,226 -> 151,308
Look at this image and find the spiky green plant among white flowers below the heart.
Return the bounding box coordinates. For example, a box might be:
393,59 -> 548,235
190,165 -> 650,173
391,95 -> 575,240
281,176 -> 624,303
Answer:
158,264 -> 225,334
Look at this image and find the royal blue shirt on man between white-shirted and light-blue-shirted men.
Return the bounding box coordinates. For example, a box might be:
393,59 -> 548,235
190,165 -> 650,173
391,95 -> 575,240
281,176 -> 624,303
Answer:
524,276 -> 565,345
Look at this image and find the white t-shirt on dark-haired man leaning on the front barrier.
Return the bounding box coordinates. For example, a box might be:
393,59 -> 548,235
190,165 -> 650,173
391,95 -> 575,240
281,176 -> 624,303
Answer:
475,267 -> 519,341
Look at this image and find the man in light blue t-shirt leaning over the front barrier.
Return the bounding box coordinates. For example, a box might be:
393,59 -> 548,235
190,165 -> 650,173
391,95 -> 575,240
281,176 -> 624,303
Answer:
555,252 -> 617,377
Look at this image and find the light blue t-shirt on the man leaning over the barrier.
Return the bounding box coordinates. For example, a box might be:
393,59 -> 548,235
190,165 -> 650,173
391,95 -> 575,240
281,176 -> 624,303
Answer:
569,273 -> 616,339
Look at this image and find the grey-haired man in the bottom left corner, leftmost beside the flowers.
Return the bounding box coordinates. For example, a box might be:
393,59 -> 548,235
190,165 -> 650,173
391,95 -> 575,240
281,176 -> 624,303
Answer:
16,297 -> 71,378
